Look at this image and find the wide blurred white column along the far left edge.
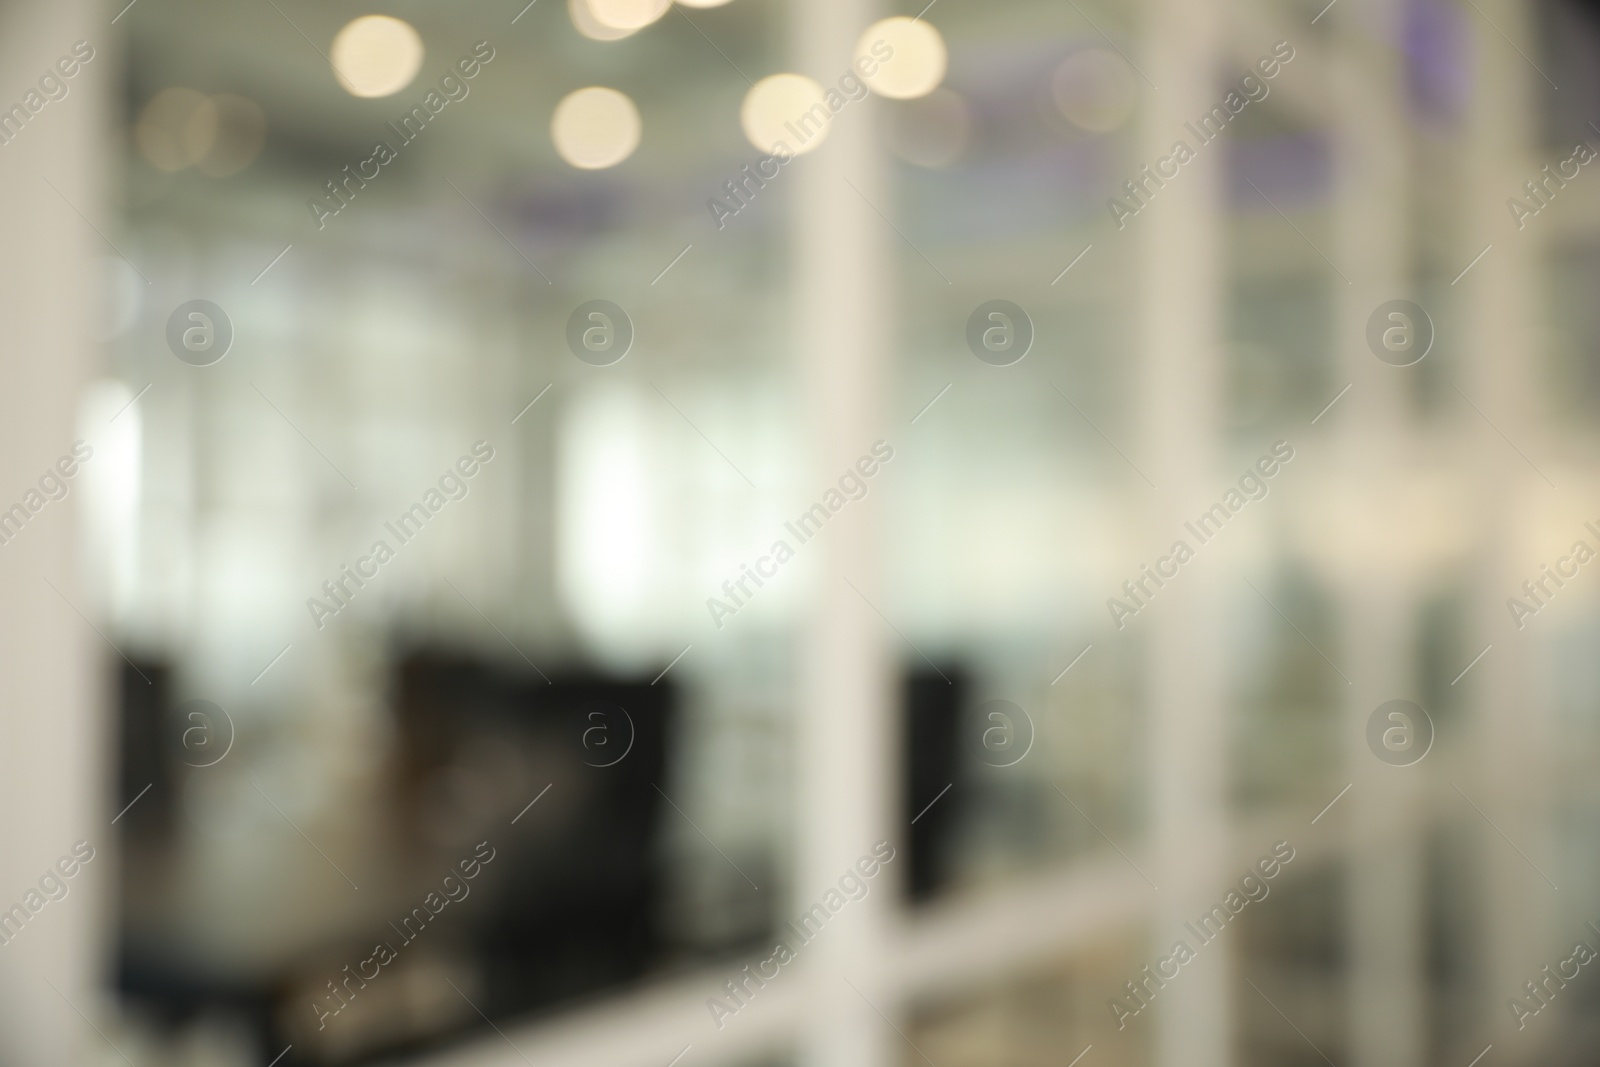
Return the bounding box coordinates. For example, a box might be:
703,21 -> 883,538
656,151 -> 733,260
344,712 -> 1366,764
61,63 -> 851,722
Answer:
0,0 -> 117,1067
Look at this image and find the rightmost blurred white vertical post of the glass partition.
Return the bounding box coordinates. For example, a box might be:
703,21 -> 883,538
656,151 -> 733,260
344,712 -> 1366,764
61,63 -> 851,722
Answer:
1450,0 -> 1548,1057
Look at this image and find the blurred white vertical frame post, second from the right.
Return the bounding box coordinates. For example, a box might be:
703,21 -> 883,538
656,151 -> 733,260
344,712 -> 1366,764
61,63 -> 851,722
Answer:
1318,0 -> 1450,1067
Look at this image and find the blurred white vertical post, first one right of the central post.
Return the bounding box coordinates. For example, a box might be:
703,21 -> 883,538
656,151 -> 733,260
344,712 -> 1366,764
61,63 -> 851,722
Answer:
1139,0 -> 1234,1067
